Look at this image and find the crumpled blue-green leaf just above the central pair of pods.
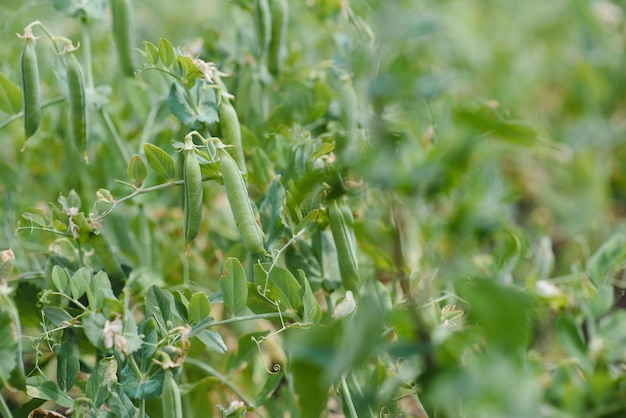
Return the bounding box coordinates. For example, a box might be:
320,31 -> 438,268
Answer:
167,80 -> 219,130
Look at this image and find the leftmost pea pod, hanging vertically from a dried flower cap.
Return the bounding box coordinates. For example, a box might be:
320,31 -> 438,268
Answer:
20,30 -> 41,139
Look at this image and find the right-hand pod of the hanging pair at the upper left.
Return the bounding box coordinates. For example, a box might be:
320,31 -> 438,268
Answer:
67,53 -> 89,162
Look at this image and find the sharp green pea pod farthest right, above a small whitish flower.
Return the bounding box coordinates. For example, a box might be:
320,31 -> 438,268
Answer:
328,200 -> 360,293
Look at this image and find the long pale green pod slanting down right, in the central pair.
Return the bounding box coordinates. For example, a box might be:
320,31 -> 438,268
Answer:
219,148 -> 266,255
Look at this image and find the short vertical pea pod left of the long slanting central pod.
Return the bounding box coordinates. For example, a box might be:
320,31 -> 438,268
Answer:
183,138 -> 202,245
